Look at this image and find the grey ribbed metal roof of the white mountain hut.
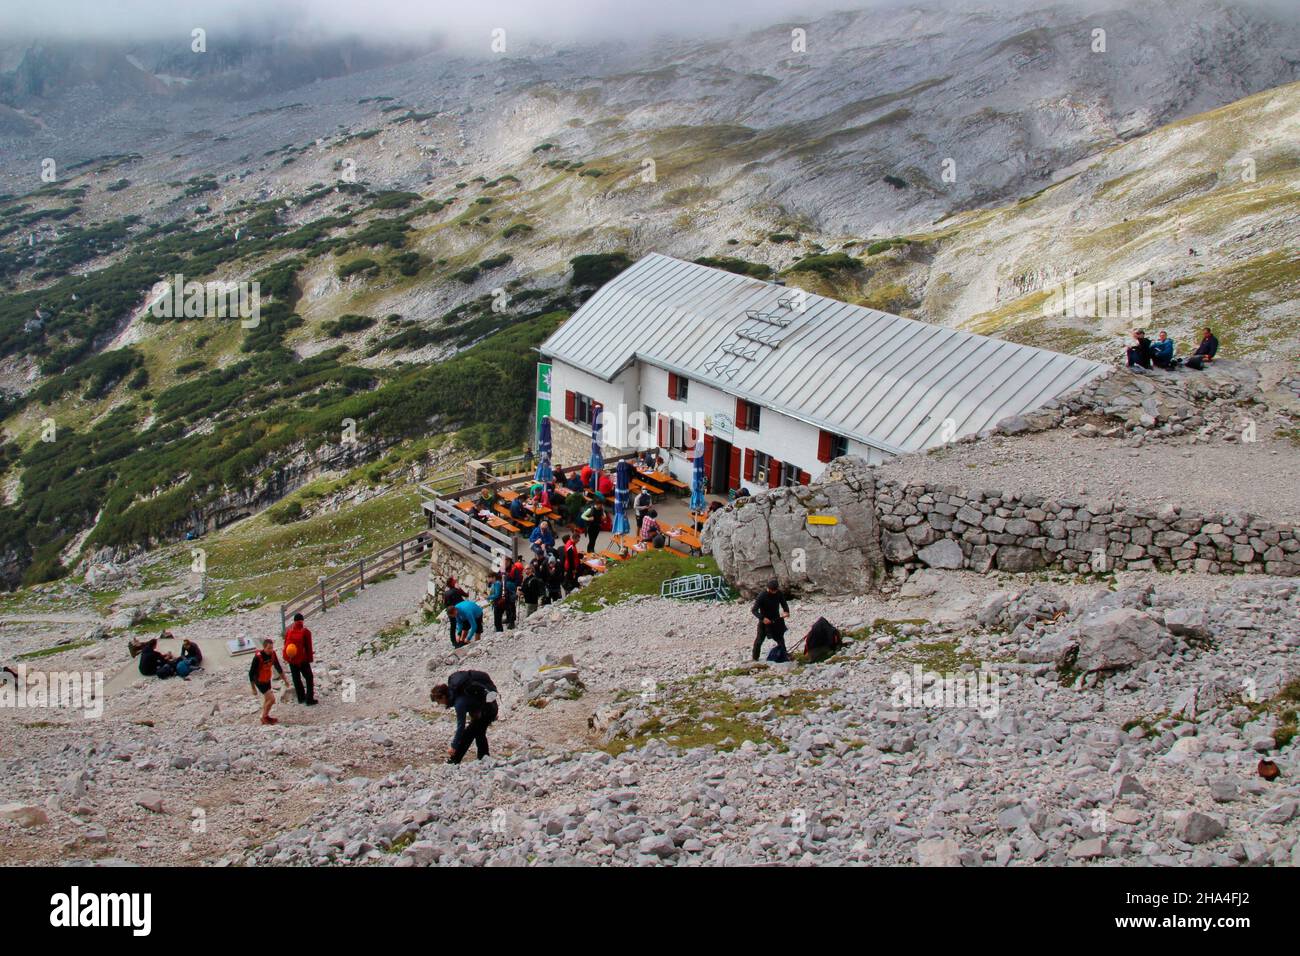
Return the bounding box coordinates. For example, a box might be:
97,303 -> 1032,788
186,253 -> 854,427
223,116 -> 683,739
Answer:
541,254 -> 1102,454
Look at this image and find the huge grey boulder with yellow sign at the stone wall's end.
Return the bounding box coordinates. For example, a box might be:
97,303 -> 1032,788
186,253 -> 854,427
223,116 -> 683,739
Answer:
702,457 -> 885,594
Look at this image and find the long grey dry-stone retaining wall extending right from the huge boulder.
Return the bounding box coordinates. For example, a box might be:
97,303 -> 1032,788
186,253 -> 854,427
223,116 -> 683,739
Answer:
876,481 -> 1300,576
